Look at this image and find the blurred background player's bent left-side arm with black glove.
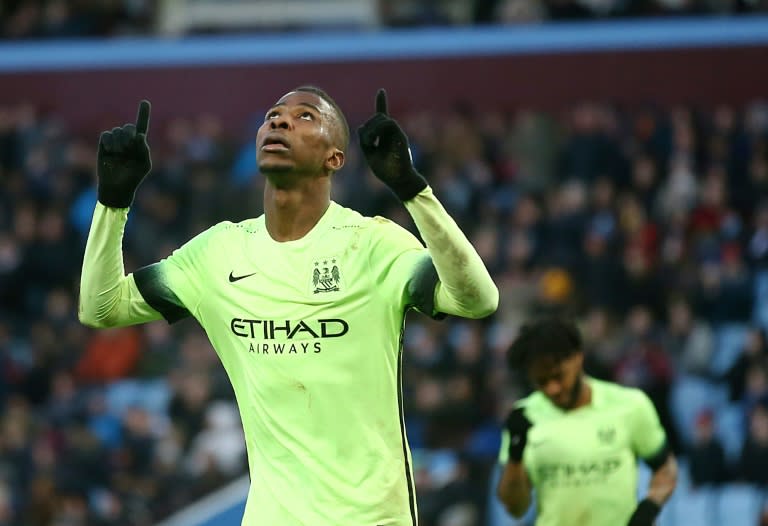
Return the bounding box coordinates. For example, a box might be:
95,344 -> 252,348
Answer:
496,407 -> 531,518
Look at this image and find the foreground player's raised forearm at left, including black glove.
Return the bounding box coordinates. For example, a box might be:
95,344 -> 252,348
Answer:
78,100 -> 161,327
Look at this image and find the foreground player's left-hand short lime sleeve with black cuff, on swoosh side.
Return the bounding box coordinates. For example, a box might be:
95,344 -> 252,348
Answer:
133,224 -> 221,323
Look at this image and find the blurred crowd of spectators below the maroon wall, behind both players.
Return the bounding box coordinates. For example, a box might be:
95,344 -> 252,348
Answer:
0,95 -> 768,526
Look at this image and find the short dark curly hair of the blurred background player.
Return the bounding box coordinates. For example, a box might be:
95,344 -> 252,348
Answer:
507,318 -> 582,369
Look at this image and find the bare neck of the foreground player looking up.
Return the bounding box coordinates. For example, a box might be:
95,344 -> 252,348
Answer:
264,176 -> 331,242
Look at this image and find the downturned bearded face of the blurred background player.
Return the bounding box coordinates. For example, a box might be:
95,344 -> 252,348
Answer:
528,353 -> 584,409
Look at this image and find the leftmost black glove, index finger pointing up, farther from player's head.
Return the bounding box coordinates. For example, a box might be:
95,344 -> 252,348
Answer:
96,100 -> 152,208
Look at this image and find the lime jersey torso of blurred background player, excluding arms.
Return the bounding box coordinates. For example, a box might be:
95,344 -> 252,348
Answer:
524,386 -> 637,526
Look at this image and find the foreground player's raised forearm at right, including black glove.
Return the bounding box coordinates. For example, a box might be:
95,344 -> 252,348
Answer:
358,90 -> 499,318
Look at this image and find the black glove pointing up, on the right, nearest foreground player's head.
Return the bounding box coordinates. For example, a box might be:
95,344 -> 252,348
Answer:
357,89 -> 427,201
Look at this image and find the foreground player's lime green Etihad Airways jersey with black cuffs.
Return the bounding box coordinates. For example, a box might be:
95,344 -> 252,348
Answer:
134,203 -> 437,526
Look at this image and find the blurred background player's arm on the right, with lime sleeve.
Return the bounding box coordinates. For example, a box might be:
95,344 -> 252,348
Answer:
627,393 -> 677,526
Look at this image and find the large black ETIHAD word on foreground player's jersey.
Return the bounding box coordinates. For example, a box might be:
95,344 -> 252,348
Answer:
229,318 -> 349,340
